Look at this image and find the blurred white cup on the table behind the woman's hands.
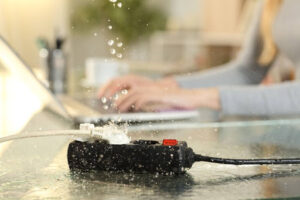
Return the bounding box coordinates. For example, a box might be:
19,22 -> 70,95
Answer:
84,58 -> 128,87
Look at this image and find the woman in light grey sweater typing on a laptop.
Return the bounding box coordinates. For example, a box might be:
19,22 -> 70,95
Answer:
99,0 -> 300,115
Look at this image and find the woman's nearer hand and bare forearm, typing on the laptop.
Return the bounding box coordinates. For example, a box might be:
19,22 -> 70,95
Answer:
115,85 -> 220,112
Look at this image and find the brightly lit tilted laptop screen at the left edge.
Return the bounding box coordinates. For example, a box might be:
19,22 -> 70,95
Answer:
0,37 -> 68,135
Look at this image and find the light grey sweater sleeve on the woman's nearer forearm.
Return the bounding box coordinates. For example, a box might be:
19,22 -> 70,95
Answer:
219,82 -> 300,116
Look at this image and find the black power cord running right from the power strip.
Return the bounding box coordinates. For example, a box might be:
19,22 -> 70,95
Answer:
194,154 -> 300,165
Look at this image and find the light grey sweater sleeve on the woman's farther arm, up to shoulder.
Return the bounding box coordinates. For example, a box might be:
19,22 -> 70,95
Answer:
175,1 -> 268,88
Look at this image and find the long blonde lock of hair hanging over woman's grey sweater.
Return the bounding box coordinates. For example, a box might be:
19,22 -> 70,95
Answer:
258,0 -> 283,66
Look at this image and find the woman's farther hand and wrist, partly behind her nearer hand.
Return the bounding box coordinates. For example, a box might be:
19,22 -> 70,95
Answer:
98,75 -> 177,98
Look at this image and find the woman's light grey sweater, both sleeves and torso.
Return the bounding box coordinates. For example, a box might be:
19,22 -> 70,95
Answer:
176,0 -> 300,116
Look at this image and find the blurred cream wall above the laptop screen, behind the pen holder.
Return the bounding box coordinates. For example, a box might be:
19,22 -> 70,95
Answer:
0,0 -> 69,67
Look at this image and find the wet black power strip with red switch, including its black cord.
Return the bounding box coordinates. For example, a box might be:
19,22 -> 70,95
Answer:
68,139 -> 300,174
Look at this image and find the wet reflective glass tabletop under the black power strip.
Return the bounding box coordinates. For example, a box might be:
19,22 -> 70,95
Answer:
0,119 -> 300,199
